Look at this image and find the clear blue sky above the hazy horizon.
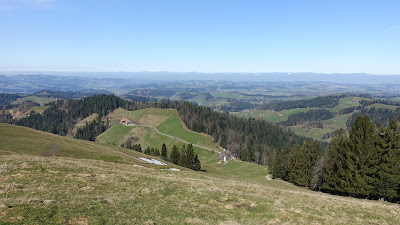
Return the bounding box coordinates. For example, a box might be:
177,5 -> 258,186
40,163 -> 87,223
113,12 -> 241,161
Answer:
0,0 -> 400,74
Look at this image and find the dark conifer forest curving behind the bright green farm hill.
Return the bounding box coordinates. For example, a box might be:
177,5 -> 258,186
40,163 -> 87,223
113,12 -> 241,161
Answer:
2,95 -> 303,164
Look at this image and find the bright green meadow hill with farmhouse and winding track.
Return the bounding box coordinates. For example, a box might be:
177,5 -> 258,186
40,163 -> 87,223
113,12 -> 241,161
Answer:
96,108 -> 225,171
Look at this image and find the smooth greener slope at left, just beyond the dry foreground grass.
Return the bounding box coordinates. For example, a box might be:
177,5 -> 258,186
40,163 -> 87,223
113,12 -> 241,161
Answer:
0,123 -> 174,169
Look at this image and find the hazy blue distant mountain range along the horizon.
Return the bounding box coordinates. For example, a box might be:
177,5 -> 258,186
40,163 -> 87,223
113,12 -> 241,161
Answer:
0,71 -> 400,84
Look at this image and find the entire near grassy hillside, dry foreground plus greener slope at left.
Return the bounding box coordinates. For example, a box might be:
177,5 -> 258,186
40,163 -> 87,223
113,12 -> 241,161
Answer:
0,124 -> 400,224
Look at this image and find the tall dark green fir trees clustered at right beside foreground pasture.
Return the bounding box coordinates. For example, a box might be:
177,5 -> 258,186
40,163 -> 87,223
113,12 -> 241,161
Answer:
273,116 -> 400,202
